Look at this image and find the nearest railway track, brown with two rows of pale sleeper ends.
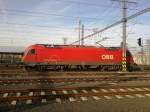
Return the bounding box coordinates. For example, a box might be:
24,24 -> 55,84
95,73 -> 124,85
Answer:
0,86 -> 150,105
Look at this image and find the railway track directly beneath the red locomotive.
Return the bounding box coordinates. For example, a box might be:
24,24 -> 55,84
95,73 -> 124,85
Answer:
0,69 -> 150,77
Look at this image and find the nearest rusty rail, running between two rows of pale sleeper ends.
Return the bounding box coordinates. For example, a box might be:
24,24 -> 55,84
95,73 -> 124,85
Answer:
0,86 -> 150,103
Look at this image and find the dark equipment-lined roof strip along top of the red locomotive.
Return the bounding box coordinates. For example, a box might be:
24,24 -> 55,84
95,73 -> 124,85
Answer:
36,44 -> 120,49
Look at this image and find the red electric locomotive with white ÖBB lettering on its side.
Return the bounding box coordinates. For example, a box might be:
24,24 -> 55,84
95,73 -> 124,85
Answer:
23,44 -> 134,70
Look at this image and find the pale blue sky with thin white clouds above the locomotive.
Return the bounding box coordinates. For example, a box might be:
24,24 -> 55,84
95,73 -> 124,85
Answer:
0,0 -> 150,47
